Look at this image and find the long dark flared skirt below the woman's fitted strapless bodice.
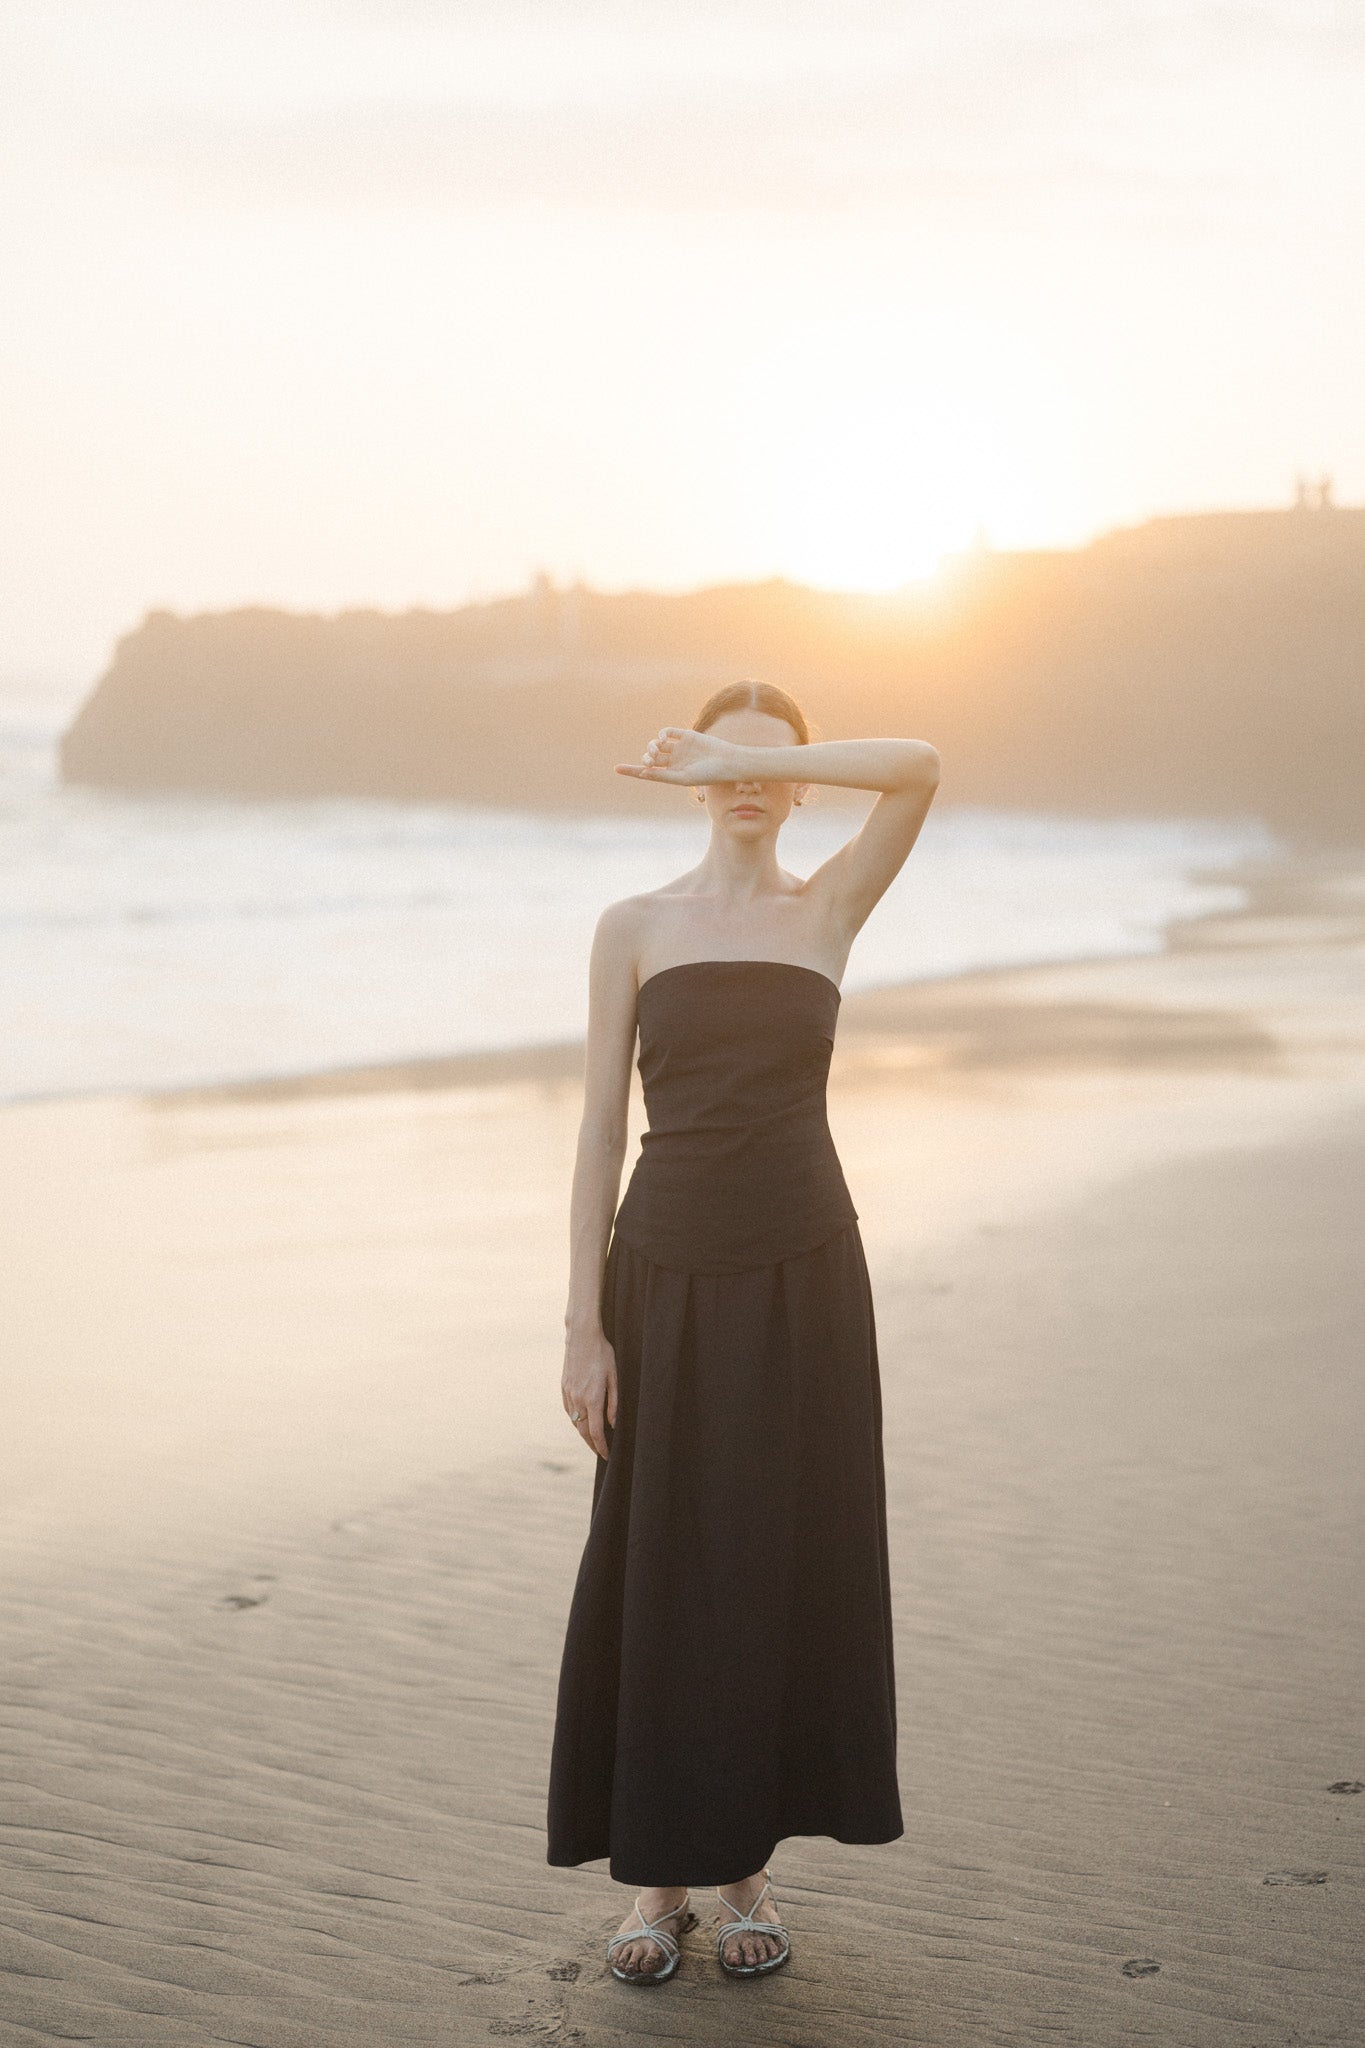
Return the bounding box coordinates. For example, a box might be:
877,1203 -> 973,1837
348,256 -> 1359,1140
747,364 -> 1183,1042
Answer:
548,1223 -> 905,1886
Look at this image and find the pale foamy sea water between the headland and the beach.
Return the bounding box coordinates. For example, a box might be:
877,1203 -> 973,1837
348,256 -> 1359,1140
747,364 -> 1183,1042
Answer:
0,696 -> 1275,1102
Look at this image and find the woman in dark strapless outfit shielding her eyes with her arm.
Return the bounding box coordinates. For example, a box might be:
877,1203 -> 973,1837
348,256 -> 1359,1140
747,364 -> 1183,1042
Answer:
548,682 -> 939,1985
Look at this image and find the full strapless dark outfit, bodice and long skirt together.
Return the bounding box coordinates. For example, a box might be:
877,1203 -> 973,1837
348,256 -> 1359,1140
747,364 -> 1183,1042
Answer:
548,961 -> 902,1886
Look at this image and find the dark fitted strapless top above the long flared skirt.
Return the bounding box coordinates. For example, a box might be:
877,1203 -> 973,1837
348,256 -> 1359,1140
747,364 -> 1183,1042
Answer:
614,961 -> 857,1272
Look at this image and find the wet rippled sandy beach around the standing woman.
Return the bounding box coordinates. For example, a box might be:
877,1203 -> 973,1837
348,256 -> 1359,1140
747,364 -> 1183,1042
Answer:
0,858 -> 1365,2048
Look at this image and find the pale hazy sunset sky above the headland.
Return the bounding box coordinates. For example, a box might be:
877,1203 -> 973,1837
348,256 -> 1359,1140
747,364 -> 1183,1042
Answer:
0,0 -> 1365,680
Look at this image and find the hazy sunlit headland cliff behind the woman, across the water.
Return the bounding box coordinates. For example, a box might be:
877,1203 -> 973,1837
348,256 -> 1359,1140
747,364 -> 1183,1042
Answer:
61,494 -> 1365,844
